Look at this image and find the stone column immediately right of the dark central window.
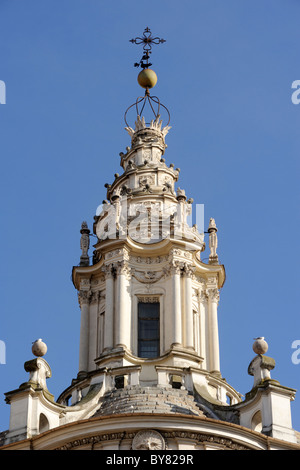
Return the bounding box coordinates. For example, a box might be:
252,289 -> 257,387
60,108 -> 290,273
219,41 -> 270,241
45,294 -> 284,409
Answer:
171,262 -> 182,346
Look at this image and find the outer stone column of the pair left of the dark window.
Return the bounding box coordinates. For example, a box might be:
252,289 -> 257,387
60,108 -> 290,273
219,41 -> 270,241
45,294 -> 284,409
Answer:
104,265 -> 114,351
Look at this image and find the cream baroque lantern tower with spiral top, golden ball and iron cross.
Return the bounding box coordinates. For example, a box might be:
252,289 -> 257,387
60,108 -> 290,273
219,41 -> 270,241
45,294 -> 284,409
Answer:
73,28 -> 237,402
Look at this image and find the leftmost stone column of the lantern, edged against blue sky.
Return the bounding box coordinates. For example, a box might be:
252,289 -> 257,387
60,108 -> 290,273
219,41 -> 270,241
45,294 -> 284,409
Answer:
78,290 -> 90,372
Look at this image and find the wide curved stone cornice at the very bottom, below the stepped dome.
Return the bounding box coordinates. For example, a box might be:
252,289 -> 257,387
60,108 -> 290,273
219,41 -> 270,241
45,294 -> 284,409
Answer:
3,413 -> 299,450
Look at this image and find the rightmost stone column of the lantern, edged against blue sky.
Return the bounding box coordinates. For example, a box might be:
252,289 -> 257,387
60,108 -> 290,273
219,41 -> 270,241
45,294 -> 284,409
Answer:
207,288 -> 220,372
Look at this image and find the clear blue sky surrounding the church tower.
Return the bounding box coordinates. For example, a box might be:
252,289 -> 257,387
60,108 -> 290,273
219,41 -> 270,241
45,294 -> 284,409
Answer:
0,0 -> 300,430
